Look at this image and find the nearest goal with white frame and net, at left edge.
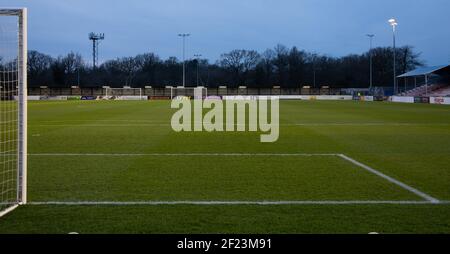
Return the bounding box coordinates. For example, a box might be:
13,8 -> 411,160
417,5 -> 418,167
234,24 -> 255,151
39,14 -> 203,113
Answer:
0,8 -> 27,216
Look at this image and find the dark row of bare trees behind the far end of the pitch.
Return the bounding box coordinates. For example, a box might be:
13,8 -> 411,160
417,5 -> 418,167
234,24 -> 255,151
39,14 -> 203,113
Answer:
28,45 -> 423,88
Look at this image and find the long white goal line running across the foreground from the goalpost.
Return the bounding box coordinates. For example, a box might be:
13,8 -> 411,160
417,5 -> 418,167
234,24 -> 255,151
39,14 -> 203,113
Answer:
27,200 -> 450,206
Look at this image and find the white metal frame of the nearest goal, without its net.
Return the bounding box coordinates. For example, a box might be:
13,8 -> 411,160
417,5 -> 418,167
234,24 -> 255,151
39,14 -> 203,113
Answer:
0,8 -> 28,217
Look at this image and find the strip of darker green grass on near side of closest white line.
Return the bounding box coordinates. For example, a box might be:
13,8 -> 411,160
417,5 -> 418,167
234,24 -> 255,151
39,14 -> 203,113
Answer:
0,205 -> 450,234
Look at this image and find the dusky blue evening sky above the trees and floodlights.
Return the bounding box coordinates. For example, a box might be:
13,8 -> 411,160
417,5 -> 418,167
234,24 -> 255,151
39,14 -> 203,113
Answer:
0,0 -> 450,66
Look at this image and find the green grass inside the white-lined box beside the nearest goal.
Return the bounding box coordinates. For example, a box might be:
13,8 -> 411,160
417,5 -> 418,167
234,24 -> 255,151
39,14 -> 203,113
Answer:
30,156 -> 419,201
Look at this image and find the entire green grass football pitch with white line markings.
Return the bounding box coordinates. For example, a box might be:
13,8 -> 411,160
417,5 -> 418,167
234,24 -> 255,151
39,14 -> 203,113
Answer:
0,101 -> 450,233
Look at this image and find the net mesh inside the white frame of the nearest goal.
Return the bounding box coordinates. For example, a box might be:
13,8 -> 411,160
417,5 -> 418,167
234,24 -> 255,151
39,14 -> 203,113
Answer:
0,15 -> 19,212
